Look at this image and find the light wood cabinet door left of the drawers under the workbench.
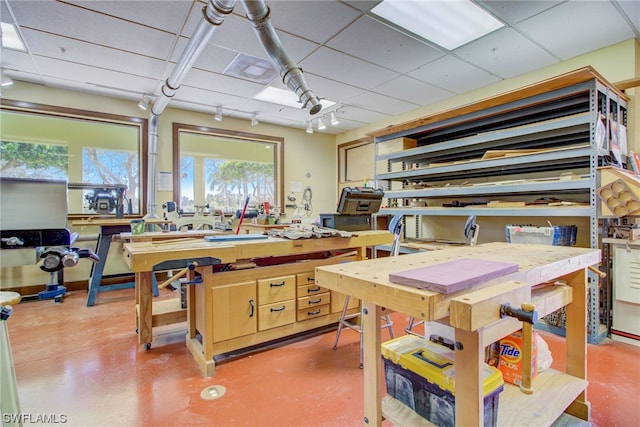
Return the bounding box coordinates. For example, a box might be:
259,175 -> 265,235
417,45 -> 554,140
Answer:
213,282 -> 258,342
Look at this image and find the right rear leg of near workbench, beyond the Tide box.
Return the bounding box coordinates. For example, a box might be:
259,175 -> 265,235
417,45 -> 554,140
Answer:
564,269 -> 591,421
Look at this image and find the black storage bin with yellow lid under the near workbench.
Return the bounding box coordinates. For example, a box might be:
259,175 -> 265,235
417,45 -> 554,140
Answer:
382,335 -> 504,427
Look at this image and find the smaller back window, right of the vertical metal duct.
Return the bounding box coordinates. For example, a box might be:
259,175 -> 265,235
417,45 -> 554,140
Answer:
174,123 -> 284,217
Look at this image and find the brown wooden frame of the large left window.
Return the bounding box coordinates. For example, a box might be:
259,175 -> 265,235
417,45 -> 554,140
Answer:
0,99 -> 149,218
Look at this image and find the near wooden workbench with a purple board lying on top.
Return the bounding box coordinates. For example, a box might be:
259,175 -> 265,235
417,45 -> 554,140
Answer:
316,243 -> 600,426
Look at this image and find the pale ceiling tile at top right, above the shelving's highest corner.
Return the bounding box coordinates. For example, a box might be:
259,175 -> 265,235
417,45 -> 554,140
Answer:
518,1 -> 634,60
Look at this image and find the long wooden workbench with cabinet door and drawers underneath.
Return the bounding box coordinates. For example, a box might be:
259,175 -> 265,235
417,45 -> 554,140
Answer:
123,231 -> 393,376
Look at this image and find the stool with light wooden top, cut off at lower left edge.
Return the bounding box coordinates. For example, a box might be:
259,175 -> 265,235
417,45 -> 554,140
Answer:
0,291 -> 22,426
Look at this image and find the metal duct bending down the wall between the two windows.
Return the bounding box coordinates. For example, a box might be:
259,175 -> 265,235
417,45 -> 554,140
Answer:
145,0 -> 236,218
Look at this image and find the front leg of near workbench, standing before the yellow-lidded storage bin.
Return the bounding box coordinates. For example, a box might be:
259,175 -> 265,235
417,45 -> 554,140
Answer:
455,328 -> 484,426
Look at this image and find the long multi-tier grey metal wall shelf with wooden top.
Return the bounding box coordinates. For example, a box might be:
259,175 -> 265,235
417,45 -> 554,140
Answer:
371,67 -> 628,342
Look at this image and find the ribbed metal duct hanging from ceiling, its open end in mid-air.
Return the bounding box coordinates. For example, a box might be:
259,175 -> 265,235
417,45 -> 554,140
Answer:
242,0 -> 322,114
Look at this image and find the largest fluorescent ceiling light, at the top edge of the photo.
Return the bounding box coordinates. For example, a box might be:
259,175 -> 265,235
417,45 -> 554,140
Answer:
371,0 -> 504,50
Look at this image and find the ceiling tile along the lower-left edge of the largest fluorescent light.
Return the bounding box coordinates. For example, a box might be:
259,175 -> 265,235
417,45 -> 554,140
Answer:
327,16 -> 444,73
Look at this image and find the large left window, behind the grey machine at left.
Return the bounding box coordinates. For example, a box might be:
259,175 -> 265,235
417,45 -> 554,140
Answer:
0,100 -> 147,215
